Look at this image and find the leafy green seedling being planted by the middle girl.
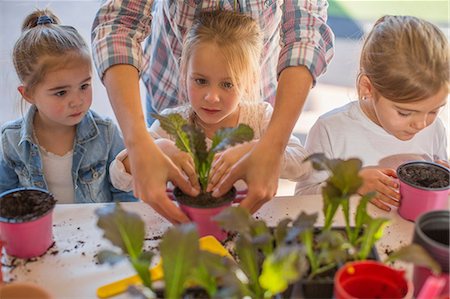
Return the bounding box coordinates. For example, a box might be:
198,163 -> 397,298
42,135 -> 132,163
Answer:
152,113 -> 253,192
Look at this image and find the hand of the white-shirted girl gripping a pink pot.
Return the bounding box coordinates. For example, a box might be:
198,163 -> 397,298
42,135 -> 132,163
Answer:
358,167 -> 400,211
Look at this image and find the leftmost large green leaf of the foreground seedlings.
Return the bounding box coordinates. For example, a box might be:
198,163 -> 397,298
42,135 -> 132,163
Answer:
95,202 -> 145,258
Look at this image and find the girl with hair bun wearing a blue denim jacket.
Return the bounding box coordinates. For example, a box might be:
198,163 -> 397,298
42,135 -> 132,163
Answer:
0,10 -> 136,203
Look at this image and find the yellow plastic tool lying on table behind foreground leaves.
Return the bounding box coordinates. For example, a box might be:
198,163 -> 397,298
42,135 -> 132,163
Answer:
97,236 -> 233,298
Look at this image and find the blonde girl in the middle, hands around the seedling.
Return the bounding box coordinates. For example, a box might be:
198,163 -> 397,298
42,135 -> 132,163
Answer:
111,11 -> 308,195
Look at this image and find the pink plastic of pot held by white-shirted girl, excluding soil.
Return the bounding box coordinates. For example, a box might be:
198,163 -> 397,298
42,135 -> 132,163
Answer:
397,161 -> 450,221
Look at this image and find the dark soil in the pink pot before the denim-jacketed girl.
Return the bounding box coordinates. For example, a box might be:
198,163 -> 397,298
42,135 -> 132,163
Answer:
0,190 -> 56,223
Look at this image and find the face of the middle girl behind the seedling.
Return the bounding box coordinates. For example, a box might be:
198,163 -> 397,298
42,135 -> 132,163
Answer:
186,43 -> 240,130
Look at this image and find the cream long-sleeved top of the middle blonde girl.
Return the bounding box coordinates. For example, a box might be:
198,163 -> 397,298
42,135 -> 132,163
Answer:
110,102 -> 311,192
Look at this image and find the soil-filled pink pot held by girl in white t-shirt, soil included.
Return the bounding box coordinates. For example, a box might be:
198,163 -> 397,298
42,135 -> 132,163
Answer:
397,161 -> 450,221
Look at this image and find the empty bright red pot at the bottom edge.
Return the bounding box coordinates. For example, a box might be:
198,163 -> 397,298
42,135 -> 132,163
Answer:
334,261 -> 414,299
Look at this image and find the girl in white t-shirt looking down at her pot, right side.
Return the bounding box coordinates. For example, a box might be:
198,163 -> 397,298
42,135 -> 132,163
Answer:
296,16 -> 449,211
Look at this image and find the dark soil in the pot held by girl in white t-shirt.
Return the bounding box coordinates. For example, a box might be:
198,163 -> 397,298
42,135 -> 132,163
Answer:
398,164 -> 450,189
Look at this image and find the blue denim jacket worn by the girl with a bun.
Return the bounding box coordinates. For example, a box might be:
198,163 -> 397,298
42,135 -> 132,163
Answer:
0,106 -> 137,203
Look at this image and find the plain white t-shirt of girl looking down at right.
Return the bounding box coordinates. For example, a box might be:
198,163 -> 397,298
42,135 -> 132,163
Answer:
295,101 -> 447,194
